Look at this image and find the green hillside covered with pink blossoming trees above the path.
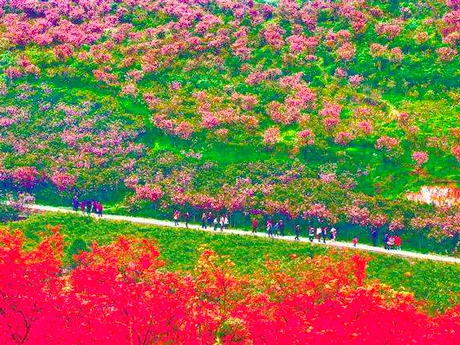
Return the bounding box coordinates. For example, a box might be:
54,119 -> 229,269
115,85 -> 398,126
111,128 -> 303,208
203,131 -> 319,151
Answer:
0,0 -> 460,242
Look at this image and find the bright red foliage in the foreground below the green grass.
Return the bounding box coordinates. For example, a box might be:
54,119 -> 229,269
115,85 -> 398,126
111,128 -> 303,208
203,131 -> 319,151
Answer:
0,229 -> 460,345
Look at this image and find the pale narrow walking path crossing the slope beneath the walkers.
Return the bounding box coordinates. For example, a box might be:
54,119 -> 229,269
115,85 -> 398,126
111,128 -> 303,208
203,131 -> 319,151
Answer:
26,205 -> 460,264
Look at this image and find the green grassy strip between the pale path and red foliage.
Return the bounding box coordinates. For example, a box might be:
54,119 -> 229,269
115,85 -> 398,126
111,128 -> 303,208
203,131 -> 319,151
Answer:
8,214 -> 460,311
